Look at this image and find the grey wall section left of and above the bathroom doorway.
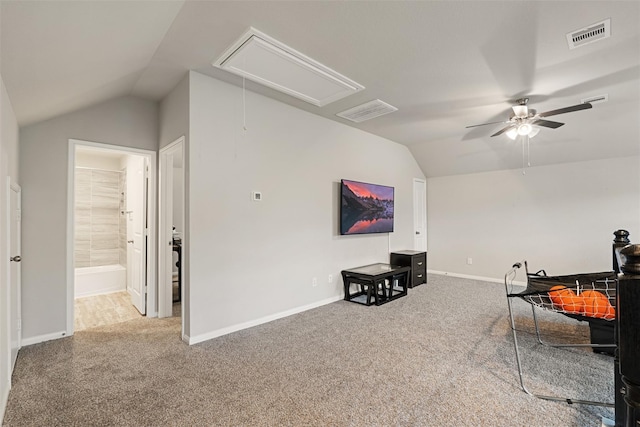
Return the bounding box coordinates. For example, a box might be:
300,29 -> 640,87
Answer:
20,97 -> 158,343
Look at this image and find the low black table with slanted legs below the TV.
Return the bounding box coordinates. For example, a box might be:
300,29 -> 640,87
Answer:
342,263 -> 411,305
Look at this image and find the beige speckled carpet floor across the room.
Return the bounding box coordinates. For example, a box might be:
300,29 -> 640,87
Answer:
4,275 -> 614,427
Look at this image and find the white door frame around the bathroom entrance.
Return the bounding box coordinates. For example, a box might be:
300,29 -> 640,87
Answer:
66,139 -> 158,336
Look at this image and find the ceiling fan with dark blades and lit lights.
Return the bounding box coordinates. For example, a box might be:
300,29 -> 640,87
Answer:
467,98 -> 593,139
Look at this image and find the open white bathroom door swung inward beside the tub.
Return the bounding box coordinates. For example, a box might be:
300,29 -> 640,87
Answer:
126,155 -> 147,314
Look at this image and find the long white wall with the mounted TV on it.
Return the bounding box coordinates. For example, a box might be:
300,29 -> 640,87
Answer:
186,72 -> 424,342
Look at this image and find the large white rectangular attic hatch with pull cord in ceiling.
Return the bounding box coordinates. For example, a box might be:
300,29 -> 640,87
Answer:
213,28 -> 364,107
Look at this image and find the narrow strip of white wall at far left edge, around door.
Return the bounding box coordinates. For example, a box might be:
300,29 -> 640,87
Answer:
0,76 -> 18,419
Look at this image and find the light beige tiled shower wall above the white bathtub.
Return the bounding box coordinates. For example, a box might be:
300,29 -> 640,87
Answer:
74,168 -> 126,268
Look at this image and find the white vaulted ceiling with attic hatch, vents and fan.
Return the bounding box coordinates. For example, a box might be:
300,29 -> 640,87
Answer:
0,0 -> 640,177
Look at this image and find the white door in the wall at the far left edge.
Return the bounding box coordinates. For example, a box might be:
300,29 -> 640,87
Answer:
9,184 -> 21,372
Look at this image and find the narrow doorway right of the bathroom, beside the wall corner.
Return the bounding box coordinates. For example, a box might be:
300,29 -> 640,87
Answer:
158,137 -> 186,324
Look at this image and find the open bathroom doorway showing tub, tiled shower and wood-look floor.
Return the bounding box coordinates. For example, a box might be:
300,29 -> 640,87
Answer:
67,140 -> 157,331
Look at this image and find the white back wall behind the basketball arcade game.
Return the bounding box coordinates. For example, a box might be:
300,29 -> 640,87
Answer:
427,157 -> 640,280
